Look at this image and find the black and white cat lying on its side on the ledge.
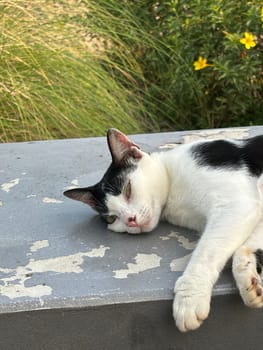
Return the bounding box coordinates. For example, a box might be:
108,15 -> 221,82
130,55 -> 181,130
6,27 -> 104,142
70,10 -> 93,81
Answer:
64,129 -> 263,331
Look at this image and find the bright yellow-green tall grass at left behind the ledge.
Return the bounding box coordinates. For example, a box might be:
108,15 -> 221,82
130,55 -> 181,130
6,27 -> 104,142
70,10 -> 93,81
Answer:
0,0 -> 155,142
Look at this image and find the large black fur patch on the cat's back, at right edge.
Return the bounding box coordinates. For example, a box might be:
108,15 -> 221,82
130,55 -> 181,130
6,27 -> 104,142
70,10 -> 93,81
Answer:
192,135 -> 263,176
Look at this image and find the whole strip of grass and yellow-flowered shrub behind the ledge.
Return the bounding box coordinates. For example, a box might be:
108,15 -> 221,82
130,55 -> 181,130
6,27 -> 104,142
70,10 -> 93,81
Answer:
0,0 -> 263,142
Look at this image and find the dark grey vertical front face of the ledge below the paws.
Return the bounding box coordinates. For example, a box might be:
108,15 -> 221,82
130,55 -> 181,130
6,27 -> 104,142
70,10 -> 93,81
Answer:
0,295 -> 263,350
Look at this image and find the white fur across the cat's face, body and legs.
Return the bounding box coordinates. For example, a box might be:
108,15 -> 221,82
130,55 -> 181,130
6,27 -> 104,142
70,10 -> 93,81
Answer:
107,139 -> 263,331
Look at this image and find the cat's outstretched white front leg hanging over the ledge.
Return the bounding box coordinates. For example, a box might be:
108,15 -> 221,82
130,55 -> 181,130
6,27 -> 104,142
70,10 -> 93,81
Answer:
173,198 -> 261,331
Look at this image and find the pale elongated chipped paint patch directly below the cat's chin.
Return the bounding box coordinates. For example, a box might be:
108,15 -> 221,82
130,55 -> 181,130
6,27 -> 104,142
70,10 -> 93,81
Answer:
113,254 -> 162,278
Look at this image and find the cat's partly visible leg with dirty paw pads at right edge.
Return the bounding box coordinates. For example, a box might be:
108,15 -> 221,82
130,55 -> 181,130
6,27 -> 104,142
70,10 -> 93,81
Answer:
233,219 -> 263,307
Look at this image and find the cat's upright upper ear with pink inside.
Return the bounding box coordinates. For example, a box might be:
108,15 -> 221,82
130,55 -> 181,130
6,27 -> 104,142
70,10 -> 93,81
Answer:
107,129 -> 143,164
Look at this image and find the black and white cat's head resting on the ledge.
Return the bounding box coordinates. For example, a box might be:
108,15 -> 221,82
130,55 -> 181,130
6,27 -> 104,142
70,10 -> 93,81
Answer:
64,129 -> 167,233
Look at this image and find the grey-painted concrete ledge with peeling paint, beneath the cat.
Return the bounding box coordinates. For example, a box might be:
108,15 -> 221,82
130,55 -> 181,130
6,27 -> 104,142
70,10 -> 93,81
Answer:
0,127 -> 263,350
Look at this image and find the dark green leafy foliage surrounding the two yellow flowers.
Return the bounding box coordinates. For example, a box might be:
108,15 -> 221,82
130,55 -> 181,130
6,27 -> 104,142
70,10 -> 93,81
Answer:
160,0 -> 263,128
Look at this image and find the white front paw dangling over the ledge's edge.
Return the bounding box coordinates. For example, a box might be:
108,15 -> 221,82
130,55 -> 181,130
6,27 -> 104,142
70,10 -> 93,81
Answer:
173,276 -> 211,332
